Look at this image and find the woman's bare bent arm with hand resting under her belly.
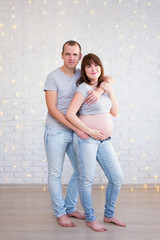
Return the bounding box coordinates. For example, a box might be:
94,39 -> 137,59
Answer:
66,92 -> 105,140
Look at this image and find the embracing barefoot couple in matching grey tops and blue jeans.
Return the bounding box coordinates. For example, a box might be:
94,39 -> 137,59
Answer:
44,40 -> 126,232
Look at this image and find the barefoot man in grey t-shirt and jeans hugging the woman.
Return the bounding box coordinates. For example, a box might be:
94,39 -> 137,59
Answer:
44,41 -> 112,227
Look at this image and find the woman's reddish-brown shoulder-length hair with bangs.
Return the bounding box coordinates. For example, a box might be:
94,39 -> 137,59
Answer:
76,53 -> 104,87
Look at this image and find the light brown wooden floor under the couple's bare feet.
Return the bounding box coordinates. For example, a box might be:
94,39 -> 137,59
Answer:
0,188 -> 160,240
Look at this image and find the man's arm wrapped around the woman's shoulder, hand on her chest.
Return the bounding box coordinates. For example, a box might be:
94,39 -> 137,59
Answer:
85,76 -> 114,104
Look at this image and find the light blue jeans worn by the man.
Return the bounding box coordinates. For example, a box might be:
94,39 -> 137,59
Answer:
44,126 -> 79,218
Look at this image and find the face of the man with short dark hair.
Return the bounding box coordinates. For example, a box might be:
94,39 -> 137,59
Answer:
62,44 -> 82,69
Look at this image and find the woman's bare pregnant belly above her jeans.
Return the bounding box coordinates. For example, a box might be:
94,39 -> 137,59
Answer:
79,113 -> 113,139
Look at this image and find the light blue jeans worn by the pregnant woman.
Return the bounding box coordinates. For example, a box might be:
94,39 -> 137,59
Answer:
73,133 -> 123,222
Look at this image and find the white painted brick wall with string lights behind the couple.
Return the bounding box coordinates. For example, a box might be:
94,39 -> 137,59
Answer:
0,0 -> 160,185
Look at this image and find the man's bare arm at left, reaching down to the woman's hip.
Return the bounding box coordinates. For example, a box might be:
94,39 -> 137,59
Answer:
45,91 -> 88,139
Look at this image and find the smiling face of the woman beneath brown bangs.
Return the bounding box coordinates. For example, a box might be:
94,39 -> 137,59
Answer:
85,63 -> 101,82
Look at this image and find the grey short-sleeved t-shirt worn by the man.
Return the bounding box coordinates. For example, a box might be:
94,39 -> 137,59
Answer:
44,68 -> 81,130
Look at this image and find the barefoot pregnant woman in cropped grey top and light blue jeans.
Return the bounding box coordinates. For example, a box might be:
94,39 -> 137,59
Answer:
66,53 -> 126,232
